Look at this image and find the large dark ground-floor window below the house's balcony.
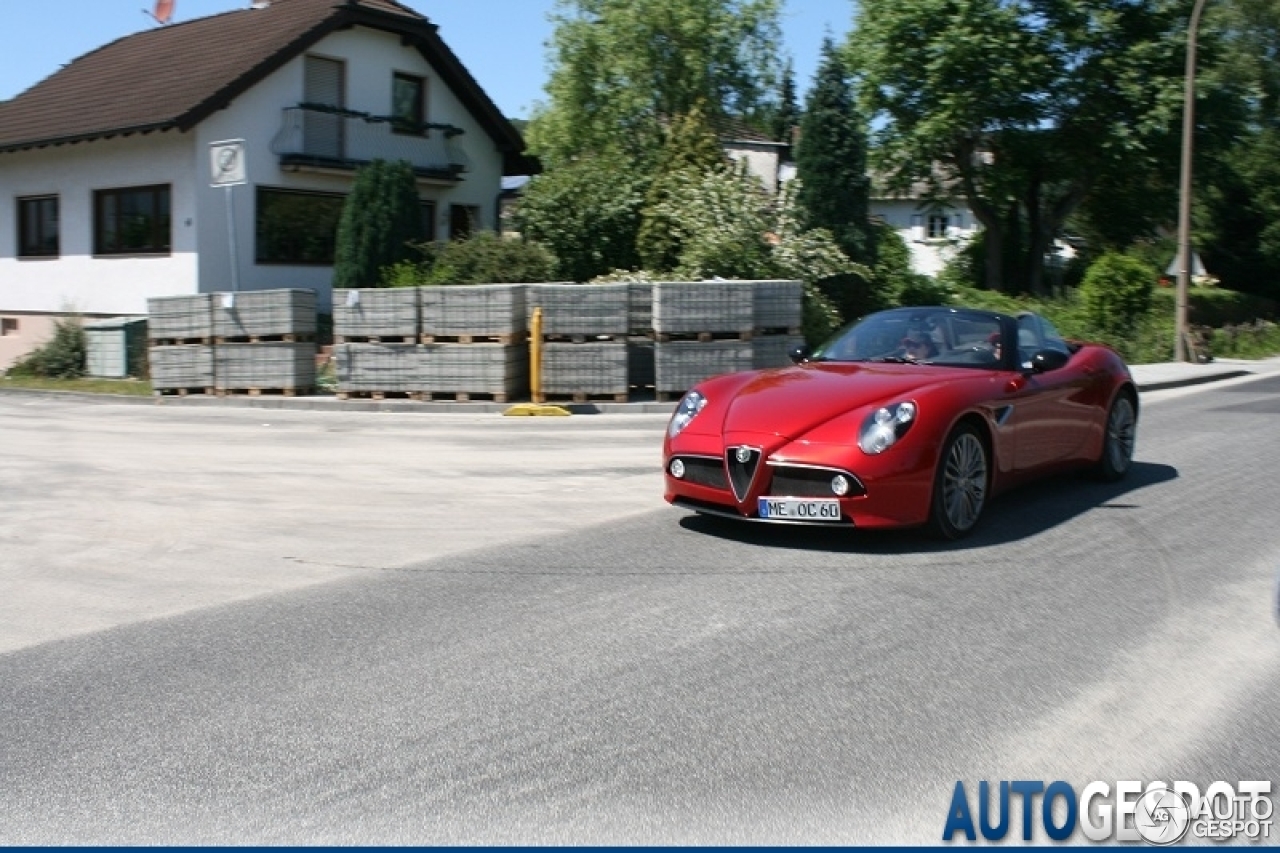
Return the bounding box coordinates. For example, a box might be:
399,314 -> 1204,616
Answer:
253,187 -> 343,266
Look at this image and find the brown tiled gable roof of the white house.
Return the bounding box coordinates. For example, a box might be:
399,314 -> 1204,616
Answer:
0,0 -> 524,162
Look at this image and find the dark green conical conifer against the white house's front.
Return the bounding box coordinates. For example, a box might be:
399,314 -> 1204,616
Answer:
333,160 -> 422,288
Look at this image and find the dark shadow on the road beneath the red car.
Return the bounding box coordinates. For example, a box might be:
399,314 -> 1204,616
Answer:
680,462 -> 1178,555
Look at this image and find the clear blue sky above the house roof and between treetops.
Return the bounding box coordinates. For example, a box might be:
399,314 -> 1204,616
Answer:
0,0 -> 854,118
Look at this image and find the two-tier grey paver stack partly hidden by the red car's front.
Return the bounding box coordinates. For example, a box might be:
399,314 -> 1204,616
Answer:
653,280 -> 755,401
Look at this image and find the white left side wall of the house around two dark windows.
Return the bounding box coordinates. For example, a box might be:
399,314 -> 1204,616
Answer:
0,132 -> 196,315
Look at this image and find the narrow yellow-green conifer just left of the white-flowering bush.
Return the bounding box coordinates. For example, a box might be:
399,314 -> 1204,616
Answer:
636,102 -> 726,270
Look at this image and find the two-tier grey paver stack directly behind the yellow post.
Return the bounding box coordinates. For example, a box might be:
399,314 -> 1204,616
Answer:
529,282 -> 635,402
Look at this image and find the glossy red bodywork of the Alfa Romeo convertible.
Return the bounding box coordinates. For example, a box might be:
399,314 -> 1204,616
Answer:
663,308 -> 1137,528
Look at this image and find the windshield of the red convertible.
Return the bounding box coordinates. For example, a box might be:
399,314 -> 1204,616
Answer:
810,307 -> 1004,369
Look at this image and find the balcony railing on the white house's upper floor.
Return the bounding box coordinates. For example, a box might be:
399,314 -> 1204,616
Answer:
271,104 -> 471,181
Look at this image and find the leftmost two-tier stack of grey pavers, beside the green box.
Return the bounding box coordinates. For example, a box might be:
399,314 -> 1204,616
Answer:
147,293 -> 214,394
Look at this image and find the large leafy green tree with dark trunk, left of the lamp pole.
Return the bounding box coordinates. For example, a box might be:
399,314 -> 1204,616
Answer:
849,0 -> 1188,292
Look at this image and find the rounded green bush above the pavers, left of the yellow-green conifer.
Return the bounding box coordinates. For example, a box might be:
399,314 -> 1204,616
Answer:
516,156 -> 650,282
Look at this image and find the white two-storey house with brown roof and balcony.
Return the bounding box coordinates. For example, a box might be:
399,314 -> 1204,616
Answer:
0,0 -> 529,369
